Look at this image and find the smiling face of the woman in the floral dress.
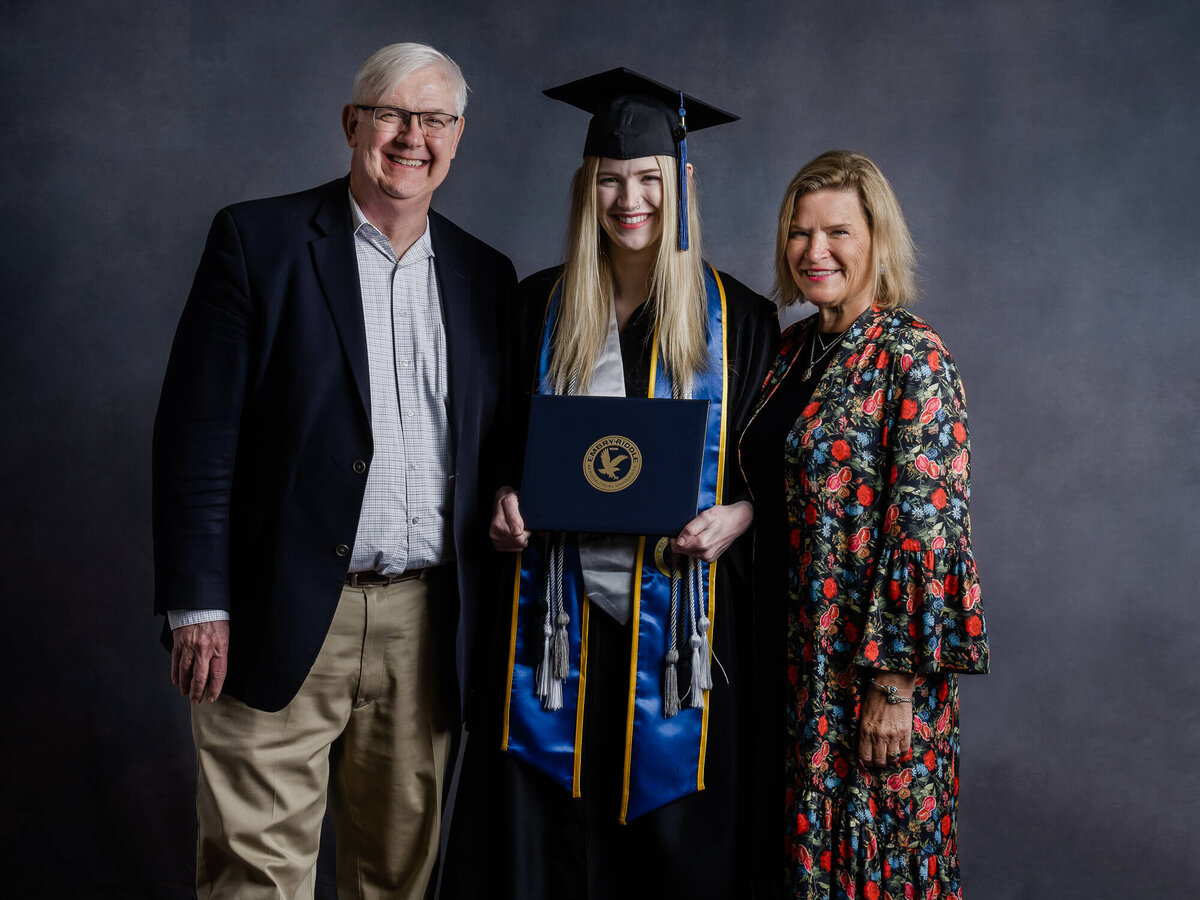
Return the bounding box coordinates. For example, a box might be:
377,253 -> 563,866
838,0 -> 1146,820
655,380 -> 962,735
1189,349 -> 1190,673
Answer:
785,188 -> 875,328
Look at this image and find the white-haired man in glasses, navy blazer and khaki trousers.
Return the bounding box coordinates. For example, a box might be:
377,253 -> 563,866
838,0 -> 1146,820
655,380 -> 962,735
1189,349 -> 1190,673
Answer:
154,43 -> 515,899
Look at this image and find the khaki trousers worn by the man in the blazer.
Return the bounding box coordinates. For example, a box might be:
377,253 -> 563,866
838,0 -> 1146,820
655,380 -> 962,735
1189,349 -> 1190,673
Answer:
192,578 -> 450,900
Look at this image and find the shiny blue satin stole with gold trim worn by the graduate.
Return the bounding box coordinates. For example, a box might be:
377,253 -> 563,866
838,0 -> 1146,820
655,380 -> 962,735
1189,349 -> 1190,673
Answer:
502,264 -> 728,823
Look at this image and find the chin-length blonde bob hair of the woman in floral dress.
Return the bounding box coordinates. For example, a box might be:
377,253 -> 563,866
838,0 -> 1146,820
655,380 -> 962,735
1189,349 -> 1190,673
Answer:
774,150 -> 917,310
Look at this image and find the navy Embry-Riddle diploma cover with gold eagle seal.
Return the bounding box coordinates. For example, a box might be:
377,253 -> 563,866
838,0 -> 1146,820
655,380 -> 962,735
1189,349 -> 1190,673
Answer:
521,394 -> 708,535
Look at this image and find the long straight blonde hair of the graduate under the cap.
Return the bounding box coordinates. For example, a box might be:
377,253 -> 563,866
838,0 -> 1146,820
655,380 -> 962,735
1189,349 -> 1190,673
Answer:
550,156 -> 709,392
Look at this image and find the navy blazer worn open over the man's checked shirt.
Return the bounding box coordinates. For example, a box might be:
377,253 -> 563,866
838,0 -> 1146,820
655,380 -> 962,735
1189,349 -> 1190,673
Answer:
154,178 -> 516,712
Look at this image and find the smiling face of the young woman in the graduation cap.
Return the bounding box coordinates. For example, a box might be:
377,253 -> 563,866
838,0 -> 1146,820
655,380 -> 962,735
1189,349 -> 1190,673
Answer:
596,156 -> 662,253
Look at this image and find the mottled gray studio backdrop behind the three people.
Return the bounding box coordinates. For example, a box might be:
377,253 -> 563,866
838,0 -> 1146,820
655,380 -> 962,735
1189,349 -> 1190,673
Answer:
0,0 -> 1200,900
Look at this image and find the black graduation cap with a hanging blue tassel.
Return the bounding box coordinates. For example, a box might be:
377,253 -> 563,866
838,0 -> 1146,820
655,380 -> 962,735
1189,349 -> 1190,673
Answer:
542,68 -> 738,250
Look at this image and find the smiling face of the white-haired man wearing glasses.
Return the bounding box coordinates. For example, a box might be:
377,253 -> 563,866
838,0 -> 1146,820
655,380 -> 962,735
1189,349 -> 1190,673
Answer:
342,66 -> 463,217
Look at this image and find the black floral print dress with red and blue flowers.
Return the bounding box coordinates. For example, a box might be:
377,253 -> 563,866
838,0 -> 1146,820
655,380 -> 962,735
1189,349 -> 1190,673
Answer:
746,308 -> 988,900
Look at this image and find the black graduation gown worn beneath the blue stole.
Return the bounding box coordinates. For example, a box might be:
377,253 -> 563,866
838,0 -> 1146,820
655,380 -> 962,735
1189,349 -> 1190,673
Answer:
440,268 -> 779,900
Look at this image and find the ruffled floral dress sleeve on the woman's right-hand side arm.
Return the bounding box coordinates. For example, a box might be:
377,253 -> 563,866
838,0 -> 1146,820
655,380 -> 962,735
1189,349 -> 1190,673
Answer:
854,329 -> 988,673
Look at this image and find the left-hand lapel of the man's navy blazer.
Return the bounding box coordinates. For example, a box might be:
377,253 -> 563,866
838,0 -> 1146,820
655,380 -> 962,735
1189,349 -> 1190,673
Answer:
310,179 -> 371,419
